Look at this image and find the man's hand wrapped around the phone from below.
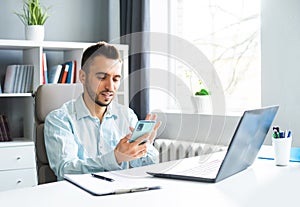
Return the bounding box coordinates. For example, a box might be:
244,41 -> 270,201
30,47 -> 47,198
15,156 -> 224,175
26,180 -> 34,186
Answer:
114,134 -> 149,164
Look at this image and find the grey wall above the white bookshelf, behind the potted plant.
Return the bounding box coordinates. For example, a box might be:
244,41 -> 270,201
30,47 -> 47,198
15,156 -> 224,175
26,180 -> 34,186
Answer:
0,0 -> 113,42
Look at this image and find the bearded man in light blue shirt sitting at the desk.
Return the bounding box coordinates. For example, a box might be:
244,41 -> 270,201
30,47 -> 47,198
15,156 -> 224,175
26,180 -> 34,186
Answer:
44,42 -> 160,180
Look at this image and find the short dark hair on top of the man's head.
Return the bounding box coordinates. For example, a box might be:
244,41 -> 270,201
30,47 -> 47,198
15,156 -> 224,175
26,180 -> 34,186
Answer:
81,41 -> 121,71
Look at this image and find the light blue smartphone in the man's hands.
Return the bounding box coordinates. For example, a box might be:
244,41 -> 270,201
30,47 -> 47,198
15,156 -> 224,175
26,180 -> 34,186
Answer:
129,120 -> 156,144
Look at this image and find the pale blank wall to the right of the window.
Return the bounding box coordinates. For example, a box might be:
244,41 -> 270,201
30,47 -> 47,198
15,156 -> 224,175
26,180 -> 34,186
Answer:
261,0 -> 300,147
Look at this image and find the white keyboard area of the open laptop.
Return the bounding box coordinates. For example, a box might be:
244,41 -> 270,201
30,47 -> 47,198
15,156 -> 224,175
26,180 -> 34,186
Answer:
176,160 -> 222,177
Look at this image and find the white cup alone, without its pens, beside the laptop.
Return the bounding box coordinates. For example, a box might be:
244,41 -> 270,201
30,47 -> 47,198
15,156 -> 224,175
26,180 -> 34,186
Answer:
272,137 -> 292,166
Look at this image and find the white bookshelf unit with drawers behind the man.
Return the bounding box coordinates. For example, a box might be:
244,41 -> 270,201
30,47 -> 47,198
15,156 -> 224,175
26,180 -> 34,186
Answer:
0,39 -> 129,190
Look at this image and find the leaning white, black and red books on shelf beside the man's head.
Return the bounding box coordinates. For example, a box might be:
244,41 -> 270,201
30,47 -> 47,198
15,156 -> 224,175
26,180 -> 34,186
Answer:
45,60 -> 76,83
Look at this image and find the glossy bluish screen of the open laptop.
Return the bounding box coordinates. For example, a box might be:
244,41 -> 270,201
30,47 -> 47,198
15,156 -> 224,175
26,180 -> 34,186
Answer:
216,106 -> 278,181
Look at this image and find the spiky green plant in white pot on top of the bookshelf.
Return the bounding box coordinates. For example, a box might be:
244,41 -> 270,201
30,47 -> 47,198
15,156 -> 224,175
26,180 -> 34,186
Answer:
15,0 -> 49,41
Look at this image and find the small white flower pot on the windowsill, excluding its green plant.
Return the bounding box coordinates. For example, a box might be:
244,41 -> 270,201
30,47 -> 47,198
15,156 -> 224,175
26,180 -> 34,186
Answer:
191,95 -> 212,114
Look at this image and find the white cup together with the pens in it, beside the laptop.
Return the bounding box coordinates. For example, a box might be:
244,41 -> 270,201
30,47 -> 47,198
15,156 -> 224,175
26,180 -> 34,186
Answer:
272,127 -> 292,166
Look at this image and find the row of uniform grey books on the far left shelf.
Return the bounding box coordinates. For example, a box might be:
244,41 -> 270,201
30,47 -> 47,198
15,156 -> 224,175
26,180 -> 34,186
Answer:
3,65 -> 34,93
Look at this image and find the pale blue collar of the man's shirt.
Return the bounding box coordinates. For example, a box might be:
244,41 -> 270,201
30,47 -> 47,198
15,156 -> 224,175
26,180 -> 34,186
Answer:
75,94 -> 118,120
